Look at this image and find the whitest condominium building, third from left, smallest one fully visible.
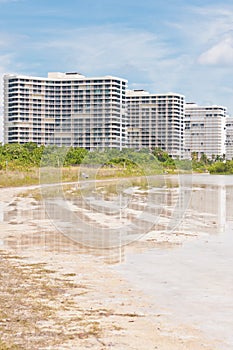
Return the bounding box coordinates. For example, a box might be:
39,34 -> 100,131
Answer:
185,103 -> 227,159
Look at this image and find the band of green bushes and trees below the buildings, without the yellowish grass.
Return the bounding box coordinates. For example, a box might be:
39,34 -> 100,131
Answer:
0,142 -> 233,174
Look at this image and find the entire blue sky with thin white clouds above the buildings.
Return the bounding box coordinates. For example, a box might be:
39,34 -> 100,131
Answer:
0,0 -> 233,140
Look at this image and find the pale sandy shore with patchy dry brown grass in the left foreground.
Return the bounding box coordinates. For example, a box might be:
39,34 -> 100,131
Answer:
0,188 -> 221,350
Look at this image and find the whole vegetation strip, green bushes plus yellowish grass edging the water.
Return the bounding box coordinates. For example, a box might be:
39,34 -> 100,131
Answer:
0,142 -> 233,186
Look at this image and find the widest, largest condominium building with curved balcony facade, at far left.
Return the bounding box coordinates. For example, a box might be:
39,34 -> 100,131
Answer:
4,73 -> 127,150
